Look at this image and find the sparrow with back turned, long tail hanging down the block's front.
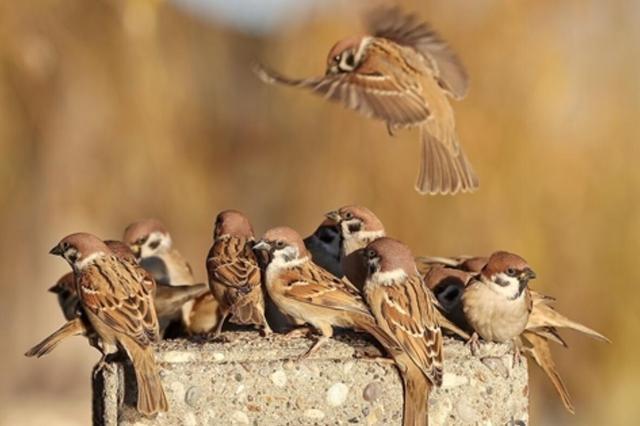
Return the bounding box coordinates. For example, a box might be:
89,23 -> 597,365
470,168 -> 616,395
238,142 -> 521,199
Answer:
361,237 -> 442,425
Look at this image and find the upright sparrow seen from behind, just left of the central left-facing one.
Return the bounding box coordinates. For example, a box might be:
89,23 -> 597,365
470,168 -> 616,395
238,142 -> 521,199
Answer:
207,210 -> 271,335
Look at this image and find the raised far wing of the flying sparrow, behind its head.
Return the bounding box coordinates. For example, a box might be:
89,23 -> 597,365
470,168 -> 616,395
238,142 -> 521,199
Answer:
366,7 -> 469,99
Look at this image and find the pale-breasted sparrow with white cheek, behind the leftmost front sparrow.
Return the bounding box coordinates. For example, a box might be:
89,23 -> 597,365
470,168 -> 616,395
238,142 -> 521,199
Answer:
123,219 -> 208,337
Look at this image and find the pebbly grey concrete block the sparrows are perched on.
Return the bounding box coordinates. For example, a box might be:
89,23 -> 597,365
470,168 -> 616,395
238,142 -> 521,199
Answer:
93,332 -> 528,426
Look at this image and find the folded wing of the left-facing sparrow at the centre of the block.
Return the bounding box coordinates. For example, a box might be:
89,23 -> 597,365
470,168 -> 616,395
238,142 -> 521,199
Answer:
281,264 -> 371,316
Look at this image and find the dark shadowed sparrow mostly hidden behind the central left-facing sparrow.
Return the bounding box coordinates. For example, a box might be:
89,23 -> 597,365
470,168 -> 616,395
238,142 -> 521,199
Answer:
304,218 -> 342,277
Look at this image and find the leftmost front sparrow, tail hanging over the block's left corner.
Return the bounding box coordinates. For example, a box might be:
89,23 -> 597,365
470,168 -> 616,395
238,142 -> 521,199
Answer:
27,233 -> 168,416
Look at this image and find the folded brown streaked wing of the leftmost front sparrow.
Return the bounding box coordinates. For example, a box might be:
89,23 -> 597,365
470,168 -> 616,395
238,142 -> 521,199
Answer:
77,256 -> 159,346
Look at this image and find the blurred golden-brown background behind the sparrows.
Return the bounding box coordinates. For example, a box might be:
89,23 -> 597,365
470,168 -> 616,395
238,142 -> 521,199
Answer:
0,0 -> 640,425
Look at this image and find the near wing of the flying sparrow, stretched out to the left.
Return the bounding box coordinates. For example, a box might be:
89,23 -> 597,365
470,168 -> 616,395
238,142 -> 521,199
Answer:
254,62 -> 429,126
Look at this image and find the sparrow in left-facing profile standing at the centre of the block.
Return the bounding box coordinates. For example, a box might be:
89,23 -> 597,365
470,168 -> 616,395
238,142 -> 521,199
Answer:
253,227 -> 396,356
